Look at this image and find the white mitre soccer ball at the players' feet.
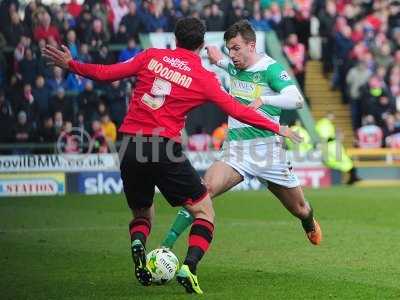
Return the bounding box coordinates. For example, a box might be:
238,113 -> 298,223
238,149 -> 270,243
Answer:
147,248 -> 179,284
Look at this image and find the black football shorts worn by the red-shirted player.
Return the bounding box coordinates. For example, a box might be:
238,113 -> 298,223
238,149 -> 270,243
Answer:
120,136 -> 207,209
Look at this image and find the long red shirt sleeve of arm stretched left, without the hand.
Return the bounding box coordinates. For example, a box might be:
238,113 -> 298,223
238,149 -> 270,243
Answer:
68,51 -> 147,81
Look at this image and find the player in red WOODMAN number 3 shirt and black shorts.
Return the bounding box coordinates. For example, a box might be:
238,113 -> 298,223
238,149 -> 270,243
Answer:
43,18 -> 301,294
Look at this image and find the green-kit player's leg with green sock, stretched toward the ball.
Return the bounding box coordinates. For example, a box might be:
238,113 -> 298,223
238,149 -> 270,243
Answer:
161,161 -> 243,249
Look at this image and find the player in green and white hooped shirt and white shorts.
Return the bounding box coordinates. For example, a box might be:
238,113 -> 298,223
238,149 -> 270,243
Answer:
162,20 -> 322,248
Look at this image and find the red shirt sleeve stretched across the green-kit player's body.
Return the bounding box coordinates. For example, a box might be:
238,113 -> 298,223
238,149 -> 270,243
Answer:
205,75 -> 280,133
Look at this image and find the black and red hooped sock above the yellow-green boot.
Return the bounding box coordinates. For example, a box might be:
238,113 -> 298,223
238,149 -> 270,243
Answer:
184,219 -> 214,274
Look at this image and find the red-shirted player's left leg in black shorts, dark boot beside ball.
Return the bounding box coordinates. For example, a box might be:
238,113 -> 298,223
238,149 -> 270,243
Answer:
120,137 -> 155,285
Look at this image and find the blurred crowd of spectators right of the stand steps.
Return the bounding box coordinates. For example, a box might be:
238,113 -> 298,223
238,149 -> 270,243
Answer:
314,0 -> 400,147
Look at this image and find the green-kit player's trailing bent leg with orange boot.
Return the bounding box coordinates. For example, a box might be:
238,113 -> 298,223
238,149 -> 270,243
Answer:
268,182 -> 322,245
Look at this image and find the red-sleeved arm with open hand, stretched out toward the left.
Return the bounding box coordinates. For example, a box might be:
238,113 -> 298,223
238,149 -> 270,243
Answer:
43,45 -> 145,81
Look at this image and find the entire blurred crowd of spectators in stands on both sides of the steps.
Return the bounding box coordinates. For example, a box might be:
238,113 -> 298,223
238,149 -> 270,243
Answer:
0,0 -> 400,153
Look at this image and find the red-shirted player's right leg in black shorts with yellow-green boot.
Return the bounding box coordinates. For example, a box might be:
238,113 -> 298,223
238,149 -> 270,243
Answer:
157,144 -> 219,294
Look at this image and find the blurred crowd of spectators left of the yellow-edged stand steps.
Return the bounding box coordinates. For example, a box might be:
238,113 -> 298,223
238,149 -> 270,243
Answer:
0,0 -> 312,152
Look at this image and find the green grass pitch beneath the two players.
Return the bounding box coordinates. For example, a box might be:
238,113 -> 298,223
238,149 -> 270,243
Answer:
0,187 -> 400,300
